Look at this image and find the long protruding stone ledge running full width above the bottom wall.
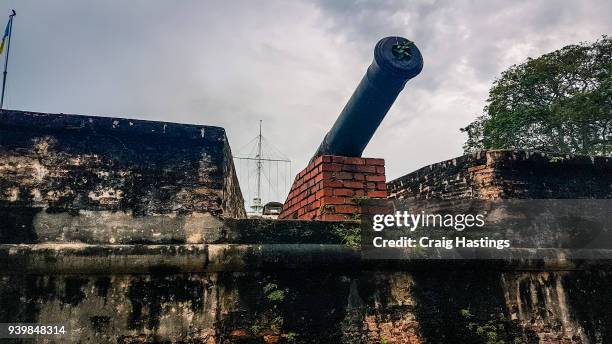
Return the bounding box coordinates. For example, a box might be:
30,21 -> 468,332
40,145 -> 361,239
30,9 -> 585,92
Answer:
0,243 -> 612,275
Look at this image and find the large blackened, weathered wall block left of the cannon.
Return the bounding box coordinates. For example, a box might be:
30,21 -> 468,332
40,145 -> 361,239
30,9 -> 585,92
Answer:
0,110 -> 245,242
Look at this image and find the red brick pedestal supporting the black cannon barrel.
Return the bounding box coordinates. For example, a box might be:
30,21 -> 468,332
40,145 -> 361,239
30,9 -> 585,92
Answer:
279,155 -> 387,221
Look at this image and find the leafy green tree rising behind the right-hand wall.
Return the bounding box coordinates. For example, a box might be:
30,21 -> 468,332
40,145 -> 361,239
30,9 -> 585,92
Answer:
461,36 -> 612,156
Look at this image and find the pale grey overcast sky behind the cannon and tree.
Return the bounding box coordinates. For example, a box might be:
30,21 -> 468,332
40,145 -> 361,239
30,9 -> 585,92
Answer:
0,0 -> 612,202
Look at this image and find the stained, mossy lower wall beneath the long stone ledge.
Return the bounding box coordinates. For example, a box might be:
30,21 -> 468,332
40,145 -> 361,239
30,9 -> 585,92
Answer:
0,266 -> 612,343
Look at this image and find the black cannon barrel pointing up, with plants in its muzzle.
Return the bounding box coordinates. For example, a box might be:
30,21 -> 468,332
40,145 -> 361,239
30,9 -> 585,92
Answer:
313,37 -> 423,159
